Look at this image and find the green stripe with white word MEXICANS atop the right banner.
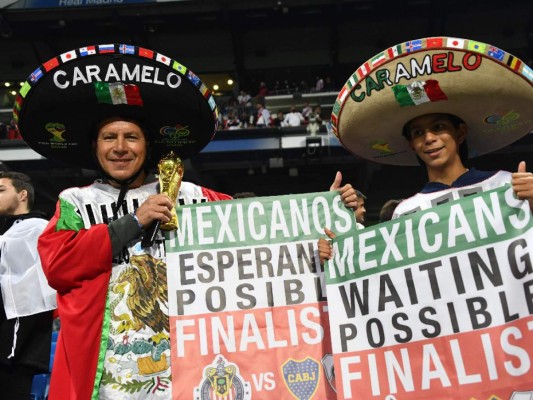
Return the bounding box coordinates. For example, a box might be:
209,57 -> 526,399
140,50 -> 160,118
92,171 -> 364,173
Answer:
326,185 -> 533,284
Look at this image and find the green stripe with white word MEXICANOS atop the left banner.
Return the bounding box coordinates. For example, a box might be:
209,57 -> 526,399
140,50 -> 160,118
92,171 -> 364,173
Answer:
165,191 -> 355,253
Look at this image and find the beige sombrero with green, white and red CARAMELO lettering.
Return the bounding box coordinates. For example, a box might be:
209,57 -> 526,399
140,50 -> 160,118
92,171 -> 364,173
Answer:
331,37 -> 533,165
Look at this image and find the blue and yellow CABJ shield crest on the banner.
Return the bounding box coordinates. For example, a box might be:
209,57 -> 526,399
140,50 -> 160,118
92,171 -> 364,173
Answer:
281,357 -> 320,400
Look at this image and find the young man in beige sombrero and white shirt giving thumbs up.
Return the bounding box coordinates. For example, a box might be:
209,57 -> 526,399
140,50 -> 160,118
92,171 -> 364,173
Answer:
319,37 -> 533,259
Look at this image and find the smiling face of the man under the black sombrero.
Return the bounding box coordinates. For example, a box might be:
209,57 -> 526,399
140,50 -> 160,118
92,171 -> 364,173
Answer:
96,119 -> 147,185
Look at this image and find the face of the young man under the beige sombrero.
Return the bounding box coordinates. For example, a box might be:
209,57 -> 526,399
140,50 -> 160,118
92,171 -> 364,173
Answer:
407,114 -> 466,169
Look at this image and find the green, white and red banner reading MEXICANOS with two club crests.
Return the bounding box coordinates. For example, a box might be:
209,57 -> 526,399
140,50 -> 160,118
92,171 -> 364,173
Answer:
165,192 -> 355,400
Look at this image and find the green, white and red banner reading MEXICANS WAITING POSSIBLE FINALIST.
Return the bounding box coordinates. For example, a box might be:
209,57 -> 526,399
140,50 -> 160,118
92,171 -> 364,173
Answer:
326,186 -> 533,400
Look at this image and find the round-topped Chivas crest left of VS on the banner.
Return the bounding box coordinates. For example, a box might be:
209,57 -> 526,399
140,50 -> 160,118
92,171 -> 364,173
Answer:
195,355 -> 252,400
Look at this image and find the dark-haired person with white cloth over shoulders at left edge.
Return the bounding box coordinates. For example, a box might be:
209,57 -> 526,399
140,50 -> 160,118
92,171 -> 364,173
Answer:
0,172 -> 57,400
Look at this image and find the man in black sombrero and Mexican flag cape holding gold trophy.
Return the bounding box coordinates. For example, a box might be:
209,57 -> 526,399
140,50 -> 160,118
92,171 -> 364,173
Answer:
14,45 -> 355,400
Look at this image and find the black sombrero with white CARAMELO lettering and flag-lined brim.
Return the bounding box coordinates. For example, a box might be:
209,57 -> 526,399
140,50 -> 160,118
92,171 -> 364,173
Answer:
13,44 -> 218,169
